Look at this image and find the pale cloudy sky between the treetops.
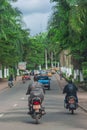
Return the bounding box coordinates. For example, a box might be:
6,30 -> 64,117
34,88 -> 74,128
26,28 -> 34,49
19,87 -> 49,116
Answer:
14,0 -> 52,35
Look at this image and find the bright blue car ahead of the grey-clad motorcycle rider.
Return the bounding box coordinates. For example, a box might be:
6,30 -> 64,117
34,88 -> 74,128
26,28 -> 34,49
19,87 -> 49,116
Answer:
37,76 -> 51,90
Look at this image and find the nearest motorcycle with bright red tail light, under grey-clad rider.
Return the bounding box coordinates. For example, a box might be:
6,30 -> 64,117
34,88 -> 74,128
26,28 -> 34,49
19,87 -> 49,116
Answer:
30,97 -> 45,124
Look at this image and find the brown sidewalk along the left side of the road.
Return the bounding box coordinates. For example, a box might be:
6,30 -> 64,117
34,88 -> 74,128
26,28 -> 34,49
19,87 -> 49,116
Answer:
0,76 -> 21,91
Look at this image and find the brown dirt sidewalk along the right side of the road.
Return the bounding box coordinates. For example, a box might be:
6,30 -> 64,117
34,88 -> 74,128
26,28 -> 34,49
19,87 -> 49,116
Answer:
56,74 -> 87,112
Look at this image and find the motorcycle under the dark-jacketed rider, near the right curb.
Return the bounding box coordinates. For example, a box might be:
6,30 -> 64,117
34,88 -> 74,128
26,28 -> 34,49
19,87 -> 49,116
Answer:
66,96 -> 78,114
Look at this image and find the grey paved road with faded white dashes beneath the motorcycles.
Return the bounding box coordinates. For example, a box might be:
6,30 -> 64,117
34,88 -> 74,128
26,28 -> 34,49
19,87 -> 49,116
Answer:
0,76 -> 87,130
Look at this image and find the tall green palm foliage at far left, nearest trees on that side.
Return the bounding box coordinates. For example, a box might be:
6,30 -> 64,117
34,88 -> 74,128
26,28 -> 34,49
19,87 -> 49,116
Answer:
0,0 -> 29,66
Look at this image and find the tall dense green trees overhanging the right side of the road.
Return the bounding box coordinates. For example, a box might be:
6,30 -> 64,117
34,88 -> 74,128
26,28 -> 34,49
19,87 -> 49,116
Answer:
48,0 -> 87,69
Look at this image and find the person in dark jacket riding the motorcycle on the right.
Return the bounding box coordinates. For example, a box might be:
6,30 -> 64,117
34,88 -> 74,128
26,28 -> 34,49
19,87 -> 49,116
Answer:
63,79 -> 78,107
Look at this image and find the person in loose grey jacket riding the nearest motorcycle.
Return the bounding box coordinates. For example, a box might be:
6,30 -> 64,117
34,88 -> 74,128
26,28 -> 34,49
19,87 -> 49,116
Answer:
26,76 -> 45,114
